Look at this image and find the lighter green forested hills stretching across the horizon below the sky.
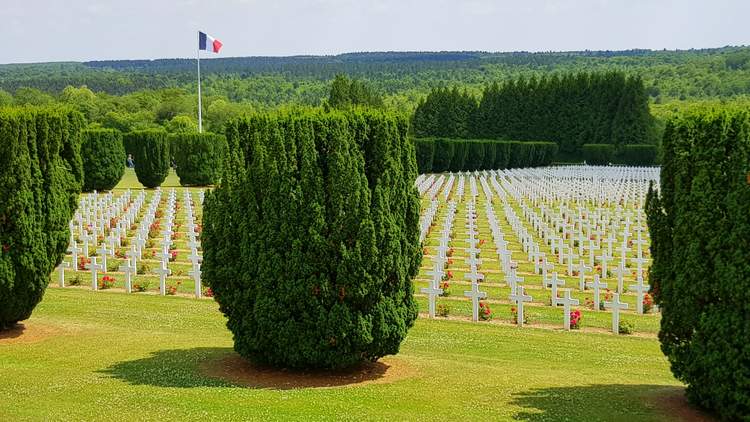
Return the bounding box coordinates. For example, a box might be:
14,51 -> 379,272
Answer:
0,47 -> 750,161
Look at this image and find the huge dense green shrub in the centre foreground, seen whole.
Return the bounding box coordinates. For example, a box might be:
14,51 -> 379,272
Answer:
202,111 -> 421,368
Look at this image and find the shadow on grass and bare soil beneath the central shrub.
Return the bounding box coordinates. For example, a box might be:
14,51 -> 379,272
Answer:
99,347 -> 413,390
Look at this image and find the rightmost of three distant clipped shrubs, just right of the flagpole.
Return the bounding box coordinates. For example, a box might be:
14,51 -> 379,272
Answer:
169,133 -> 227,186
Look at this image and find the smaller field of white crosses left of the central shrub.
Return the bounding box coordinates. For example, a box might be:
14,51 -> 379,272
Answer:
53,188 -> 212,298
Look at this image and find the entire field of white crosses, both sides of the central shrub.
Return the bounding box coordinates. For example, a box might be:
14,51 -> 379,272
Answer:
52,166 -> 659,334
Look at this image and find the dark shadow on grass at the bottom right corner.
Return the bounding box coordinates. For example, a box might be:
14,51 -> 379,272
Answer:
511,384 -> 716,421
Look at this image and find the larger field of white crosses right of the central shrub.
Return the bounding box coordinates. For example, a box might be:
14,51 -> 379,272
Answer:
415,166 -> 659,334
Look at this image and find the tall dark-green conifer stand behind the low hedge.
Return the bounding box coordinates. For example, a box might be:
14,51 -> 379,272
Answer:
413,72 -> 658,157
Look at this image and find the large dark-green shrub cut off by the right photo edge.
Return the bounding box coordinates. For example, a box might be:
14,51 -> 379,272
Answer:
646,111 -> 750,420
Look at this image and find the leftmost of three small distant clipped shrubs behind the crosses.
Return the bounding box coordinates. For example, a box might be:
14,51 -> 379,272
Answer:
81,129 -> 126,192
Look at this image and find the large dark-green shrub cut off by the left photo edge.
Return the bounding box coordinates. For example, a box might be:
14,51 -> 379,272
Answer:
0,108 -> 83,330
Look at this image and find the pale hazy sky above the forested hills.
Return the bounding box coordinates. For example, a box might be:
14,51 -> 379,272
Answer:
0,0 -> 750,63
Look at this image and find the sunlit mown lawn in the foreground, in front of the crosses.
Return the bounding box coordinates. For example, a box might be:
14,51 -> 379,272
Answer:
0,288 -> 700,421
